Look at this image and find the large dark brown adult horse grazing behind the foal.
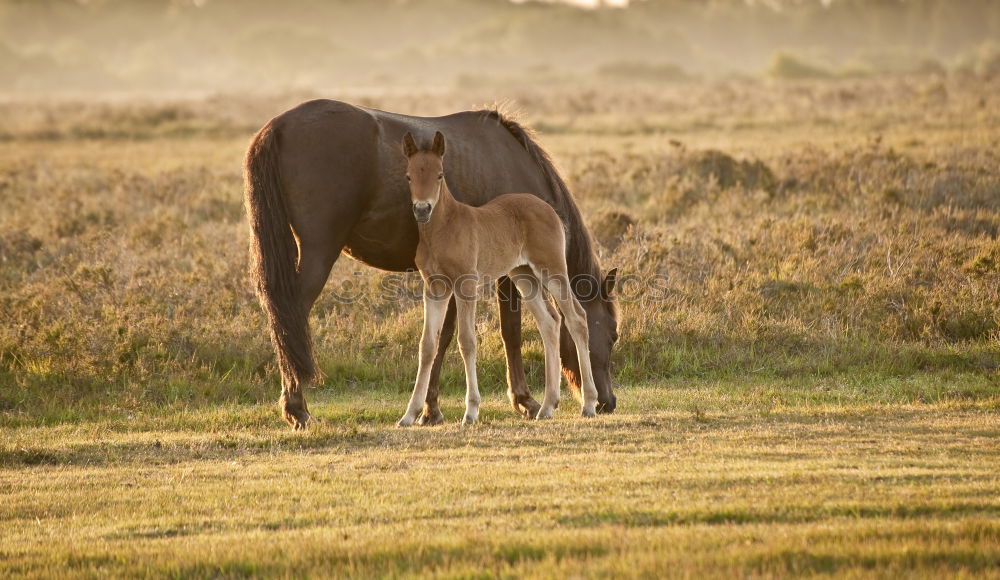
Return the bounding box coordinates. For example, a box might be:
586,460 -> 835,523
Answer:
245,100 -> 618,429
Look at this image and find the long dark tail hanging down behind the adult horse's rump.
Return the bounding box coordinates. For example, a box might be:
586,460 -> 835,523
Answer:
244,123 -> 316,392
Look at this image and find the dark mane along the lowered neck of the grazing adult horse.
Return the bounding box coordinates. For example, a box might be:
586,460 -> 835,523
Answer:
483,104 -> 604,284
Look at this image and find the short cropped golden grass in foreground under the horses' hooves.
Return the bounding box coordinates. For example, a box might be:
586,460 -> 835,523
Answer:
0,386 -> 1000,577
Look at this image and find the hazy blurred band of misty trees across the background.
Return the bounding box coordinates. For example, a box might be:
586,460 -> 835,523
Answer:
0,0 -> 1000,92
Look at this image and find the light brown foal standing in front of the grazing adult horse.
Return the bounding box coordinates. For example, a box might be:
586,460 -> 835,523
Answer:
397,132 -> 597,427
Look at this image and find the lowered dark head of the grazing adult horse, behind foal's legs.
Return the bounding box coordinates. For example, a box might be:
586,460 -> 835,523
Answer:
559,268 -> 618,413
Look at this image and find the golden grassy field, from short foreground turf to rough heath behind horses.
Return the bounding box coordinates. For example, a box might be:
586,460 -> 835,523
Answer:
0,75 -> 1000,577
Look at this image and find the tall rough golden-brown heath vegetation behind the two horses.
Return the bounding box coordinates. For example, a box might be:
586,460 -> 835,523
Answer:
0,77 -> 1000,417
